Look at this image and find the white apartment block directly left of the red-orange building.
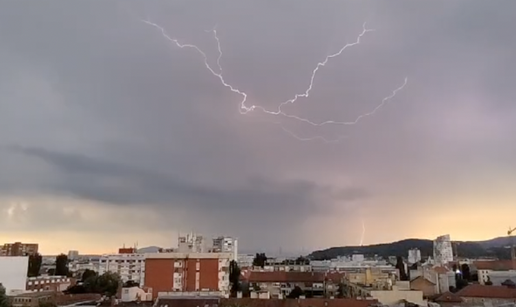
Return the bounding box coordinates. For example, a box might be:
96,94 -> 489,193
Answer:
98,253 -> 145,285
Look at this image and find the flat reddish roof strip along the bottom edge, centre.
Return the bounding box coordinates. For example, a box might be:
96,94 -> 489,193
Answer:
219,298 -> 378,307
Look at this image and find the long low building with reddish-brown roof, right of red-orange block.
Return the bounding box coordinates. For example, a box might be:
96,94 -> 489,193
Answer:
242,271 -> 345,298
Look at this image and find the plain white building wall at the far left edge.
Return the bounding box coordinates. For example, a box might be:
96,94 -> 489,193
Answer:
0,256 -> 29,295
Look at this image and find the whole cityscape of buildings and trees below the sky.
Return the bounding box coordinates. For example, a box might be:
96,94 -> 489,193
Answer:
0,233 -> 516,307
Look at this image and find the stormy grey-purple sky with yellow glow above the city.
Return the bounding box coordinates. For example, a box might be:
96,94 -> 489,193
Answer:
0,0 -> 516,254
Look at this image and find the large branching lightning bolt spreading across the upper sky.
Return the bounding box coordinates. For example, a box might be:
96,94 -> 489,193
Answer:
141,20 -> 408,143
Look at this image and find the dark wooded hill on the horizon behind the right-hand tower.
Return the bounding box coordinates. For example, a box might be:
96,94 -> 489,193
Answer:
308,237 -> 511,260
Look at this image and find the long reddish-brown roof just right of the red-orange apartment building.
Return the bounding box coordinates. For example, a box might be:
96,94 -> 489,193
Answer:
246,271 -> 345,283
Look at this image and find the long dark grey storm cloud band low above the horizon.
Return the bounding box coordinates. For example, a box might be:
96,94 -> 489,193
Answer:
11,147 -> 367,215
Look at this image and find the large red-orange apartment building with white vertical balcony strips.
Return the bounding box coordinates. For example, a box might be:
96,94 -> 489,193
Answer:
144,253 -> 234,298
